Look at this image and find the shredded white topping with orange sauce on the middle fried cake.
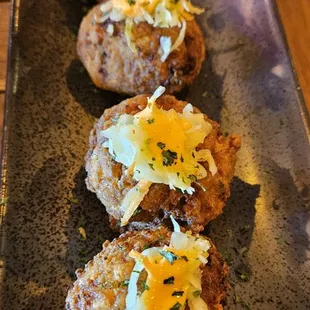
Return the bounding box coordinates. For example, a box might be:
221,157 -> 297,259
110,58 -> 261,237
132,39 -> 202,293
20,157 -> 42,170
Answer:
101,87 -> 217,225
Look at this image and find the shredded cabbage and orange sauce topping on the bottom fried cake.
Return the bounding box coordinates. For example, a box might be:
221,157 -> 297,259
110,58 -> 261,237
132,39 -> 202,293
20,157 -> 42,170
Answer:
126,218 -> 210,310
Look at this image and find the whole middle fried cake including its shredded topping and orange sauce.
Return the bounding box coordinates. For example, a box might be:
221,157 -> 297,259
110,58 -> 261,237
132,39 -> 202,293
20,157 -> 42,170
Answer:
86,87 -> 241,231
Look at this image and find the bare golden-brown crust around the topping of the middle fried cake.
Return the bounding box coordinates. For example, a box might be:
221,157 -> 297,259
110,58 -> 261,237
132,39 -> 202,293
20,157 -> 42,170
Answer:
86,95 -> 241,231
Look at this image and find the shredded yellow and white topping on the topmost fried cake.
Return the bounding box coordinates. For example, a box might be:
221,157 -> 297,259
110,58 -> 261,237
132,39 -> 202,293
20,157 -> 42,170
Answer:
95,0 -> 204,62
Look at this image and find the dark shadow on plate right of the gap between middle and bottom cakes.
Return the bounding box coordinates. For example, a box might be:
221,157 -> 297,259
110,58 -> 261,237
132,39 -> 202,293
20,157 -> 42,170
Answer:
206,177 -> 260,308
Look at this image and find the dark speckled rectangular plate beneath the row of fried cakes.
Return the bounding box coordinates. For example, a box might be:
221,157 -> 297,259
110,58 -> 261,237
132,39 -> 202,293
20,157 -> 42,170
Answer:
0,0 -> 310,310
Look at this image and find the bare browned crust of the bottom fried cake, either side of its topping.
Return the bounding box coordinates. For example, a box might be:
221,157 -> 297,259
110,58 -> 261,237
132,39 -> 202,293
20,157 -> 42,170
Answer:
66,227 -> 228,310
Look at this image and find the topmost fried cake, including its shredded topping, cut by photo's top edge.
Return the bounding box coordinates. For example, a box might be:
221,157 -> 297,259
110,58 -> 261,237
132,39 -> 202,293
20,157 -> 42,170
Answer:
77,0 -> 205,95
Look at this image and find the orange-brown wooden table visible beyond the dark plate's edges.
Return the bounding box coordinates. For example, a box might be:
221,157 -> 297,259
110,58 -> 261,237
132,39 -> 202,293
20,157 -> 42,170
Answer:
0,0 -> 310,110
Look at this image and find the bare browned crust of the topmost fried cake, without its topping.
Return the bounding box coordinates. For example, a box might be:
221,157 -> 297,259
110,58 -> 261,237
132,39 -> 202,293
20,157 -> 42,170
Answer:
77,5 -> 205,95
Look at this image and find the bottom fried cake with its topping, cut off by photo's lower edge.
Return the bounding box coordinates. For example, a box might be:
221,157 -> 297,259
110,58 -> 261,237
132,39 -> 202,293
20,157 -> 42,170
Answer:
66,227 -> 228,310
